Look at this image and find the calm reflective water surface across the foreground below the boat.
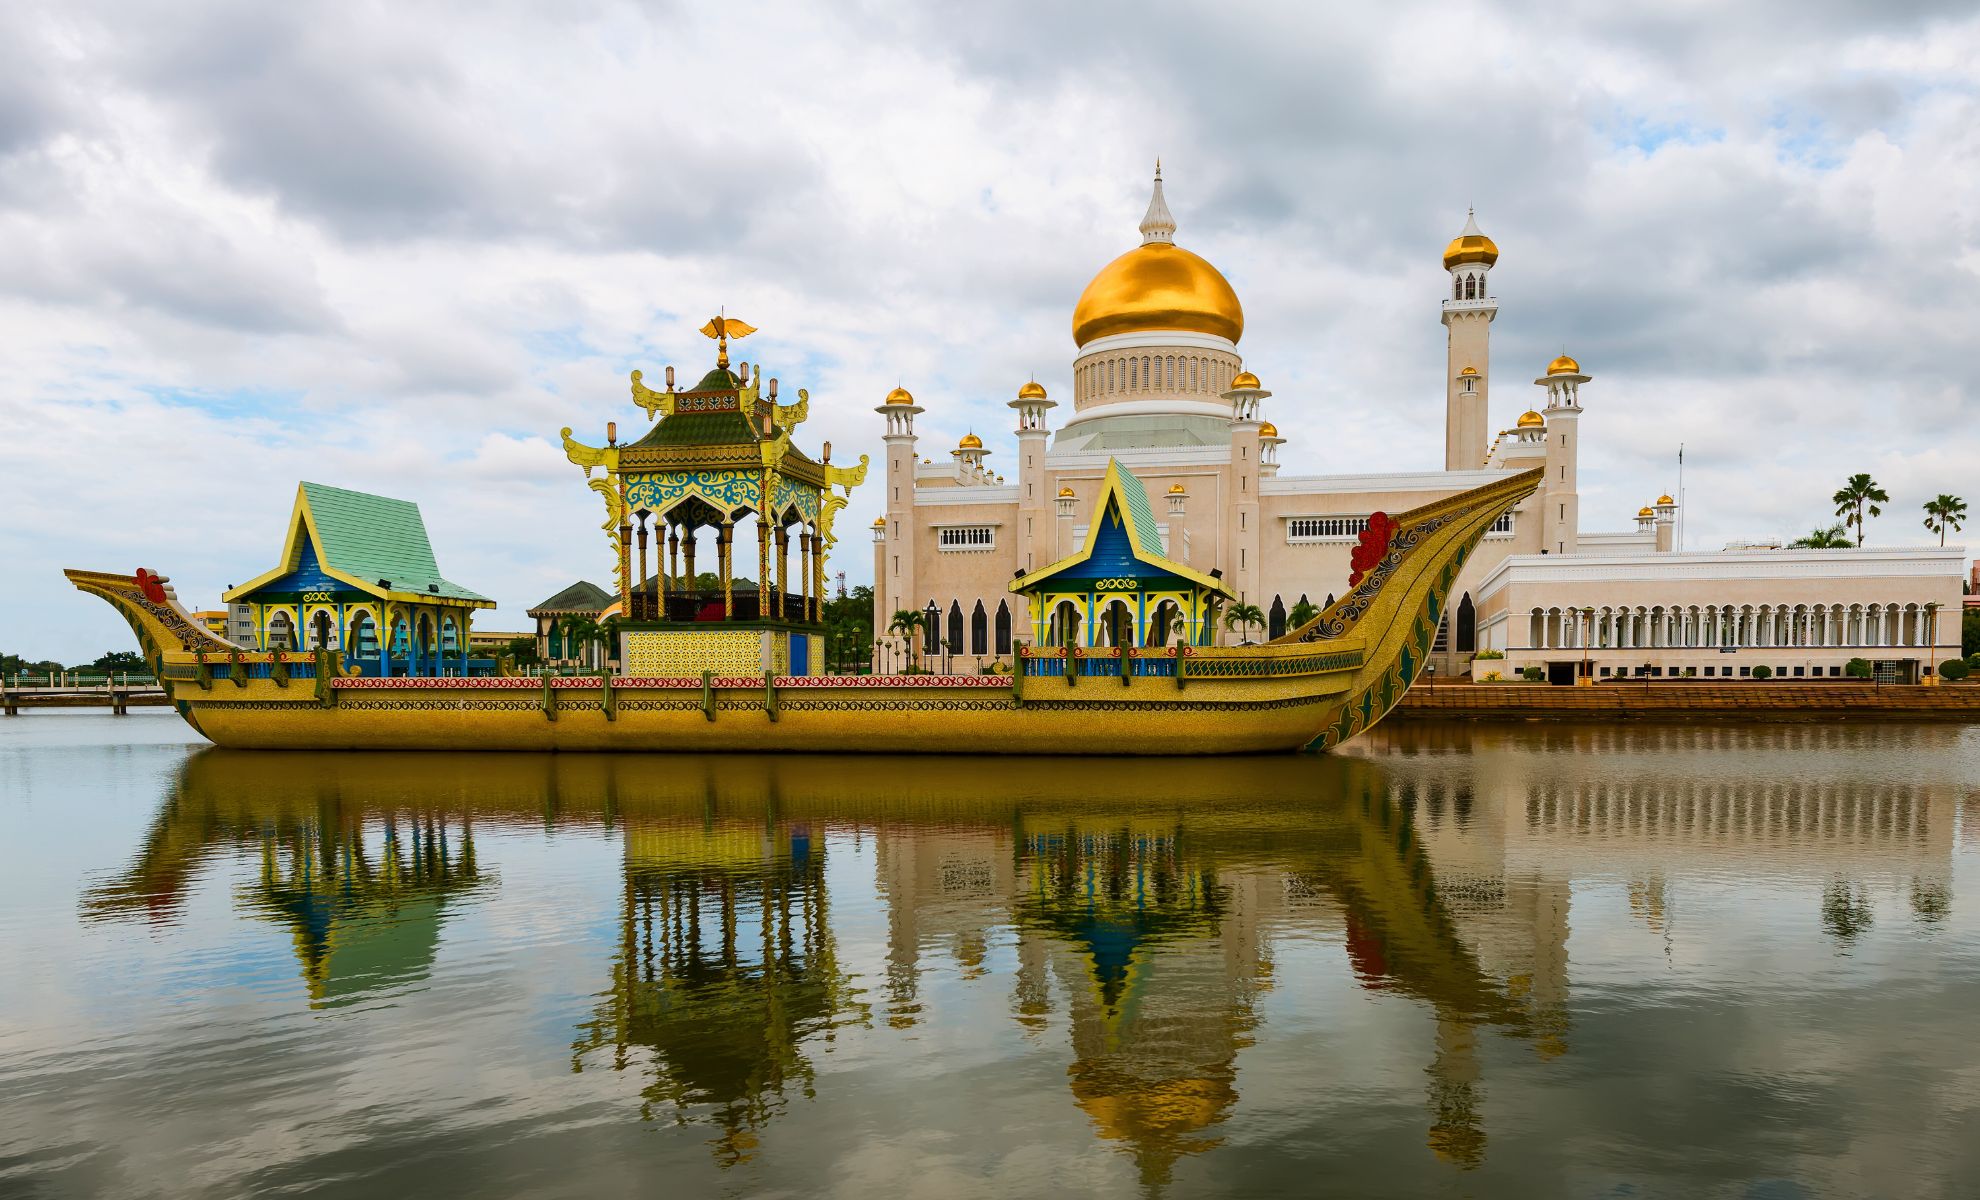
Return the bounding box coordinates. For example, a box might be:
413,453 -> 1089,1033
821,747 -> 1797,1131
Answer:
0,713 -> 1980,1198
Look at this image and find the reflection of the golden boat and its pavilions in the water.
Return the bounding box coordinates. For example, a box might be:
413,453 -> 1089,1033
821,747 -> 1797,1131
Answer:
96,750 -> 1560,1182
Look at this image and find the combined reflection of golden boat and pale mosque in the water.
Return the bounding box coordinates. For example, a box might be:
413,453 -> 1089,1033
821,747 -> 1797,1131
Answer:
85,744 -> 1974,1184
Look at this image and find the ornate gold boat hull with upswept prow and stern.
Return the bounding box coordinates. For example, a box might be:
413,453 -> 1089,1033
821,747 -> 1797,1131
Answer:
67,471 -> 1540,754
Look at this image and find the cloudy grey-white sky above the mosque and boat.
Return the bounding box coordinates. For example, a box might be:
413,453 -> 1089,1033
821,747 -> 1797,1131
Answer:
0,0 -> 1980,661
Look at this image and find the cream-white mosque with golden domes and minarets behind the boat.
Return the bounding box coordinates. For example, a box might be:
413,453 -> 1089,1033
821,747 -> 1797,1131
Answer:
873,168 -> 1964,683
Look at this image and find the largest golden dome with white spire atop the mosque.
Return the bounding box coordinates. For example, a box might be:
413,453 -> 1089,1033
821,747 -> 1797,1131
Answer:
1073,166 -> 1243,347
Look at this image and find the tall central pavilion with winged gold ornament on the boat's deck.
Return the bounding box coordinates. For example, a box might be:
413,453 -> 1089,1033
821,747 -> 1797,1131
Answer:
562,317 -> 867,677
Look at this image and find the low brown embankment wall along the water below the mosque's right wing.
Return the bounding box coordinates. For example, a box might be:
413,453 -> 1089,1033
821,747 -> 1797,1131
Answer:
1390,681 -> 1980,721
